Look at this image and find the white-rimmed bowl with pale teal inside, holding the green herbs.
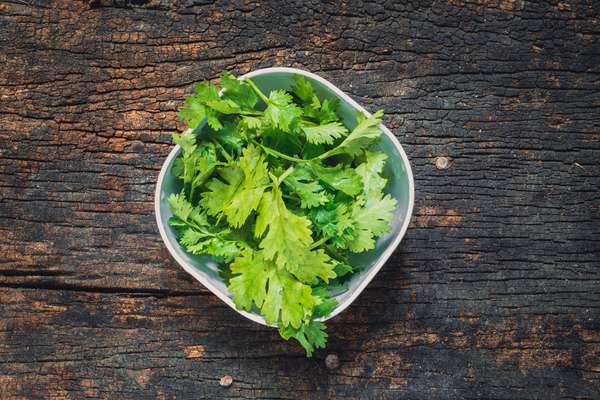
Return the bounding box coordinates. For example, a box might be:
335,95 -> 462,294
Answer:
154,68 -> 414,325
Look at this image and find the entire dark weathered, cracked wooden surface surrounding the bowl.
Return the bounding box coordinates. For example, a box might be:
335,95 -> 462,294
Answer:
0,0 -> 600,400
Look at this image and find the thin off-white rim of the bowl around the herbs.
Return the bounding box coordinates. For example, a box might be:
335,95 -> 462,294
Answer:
154,67 -> 415,326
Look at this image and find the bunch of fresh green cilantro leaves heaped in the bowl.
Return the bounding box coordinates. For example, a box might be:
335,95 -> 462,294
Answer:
169,72 -> 396,357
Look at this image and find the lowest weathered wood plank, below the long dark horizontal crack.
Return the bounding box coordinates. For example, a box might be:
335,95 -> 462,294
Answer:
0,288 -> 600,399
